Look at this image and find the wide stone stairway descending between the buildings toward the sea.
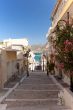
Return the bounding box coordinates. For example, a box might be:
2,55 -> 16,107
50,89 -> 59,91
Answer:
4,72 -> 70,110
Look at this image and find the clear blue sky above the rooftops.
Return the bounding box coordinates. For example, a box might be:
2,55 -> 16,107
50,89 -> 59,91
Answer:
0,0 -> 56,44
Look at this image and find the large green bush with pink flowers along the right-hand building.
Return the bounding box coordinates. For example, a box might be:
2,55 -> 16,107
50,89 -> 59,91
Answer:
55,21 -> 73,71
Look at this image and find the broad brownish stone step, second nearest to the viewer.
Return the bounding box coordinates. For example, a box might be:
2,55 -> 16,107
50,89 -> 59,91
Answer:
7,91 -> 58,99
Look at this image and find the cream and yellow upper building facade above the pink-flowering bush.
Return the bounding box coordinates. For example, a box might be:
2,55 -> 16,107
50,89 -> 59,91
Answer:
51,0 -> 73,29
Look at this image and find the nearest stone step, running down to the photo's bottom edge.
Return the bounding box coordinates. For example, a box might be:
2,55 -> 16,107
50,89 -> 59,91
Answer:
5,100 -> 70,110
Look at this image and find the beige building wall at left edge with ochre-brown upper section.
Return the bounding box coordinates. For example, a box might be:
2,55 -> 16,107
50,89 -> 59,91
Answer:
0,50 -> 17,87
